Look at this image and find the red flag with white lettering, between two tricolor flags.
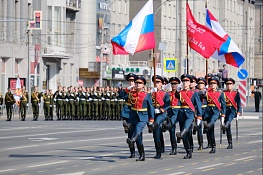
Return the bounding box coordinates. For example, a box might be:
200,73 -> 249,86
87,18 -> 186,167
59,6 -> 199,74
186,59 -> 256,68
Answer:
186,3 -> 226,58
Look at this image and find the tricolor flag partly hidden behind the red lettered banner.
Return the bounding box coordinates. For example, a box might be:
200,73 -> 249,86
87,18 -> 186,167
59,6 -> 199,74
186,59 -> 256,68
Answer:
206,9 -> 245,67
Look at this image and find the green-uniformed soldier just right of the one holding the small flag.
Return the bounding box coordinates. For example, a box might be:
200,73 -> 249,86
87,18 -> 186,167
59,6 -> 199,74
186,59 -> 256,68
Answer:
31,86 -> 42,121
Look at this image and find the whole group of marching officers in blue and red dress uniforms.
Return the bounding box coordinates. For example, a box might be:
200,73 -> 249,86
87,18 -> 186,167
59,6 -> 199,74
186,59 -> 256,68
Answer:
120,74 -> 241,161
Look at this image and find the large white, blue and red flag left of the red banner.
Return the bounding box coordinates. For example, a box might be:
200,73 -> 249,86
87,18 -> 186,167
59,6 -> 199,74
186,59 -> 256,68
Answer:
111,0 -> 155,55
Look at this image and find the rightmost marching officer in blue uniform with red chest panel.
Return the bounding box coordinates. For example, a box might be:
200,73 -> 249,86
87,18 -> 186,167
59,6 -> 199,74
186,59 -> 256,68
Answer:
221,78 -> 241,149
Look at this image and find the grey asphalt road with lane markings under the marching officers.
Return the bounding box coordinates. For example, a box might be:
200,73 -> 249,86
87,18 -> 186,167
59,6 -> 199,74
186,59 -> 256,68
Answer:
0,104 -> 263,175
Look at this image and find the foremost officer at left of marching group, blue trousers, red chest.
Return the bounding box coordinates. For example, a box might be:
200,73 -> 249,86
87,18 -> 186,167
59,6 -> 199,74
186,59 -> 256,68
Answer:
126,76 -> 154,161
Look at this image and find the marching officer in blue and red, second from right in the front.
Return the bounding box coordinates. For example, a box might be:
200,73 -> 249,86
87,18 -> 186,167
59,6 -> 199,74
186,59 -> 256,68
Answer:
203,77 -> 226,153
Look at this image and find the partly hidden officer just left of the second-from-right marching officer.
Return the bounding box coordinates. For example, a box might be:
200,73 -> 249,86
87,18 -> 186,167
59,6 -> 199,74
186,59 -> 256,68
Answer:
193,77 -> 207,150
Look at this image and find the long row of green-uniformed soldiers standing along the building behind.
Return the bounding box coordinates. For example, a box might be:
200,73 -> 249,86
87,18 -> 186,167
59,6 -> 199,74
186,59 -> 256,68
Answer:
0,86 -> 130,121
